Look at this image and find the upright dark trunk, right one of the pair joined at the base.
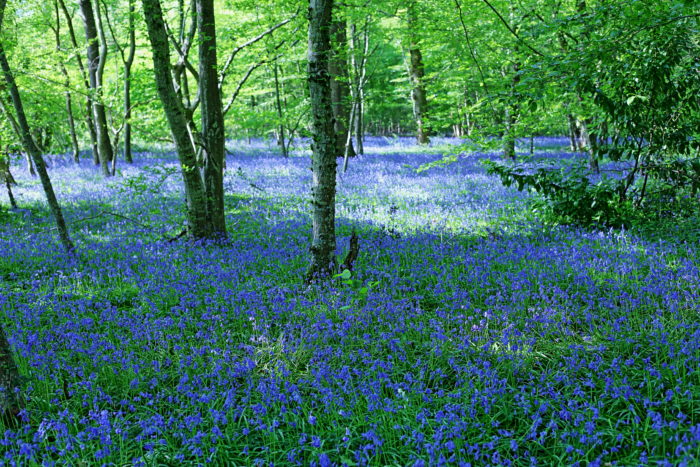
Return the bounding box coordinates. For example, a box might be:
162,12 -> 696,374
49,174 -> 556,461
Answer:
197,0 -> 226,238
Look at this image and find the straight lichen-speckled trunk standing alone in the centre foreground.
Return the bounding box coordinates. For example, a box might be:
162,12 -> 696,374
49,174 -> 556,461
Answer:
306,0 -> 337,282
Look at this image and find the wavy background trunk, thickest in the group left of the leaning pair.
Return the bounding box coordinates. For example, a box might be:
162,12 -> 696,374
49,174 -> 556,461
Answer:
80,0 -> 114,177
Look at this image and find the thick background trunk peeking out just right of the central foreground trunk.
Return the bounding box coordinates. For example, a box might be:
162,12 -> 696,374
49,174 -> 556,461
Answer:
328,20 -> 355,157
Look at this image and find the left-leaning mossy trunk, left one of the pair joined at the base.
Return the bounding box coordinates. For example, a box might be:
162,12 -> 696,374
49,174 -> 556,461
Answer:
142,0 -> 210,239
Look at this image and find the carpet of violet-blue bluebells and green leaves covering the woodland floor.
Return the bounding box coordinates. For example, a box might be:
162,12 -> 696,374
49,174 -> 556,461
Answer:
0,138 -> 700,467
